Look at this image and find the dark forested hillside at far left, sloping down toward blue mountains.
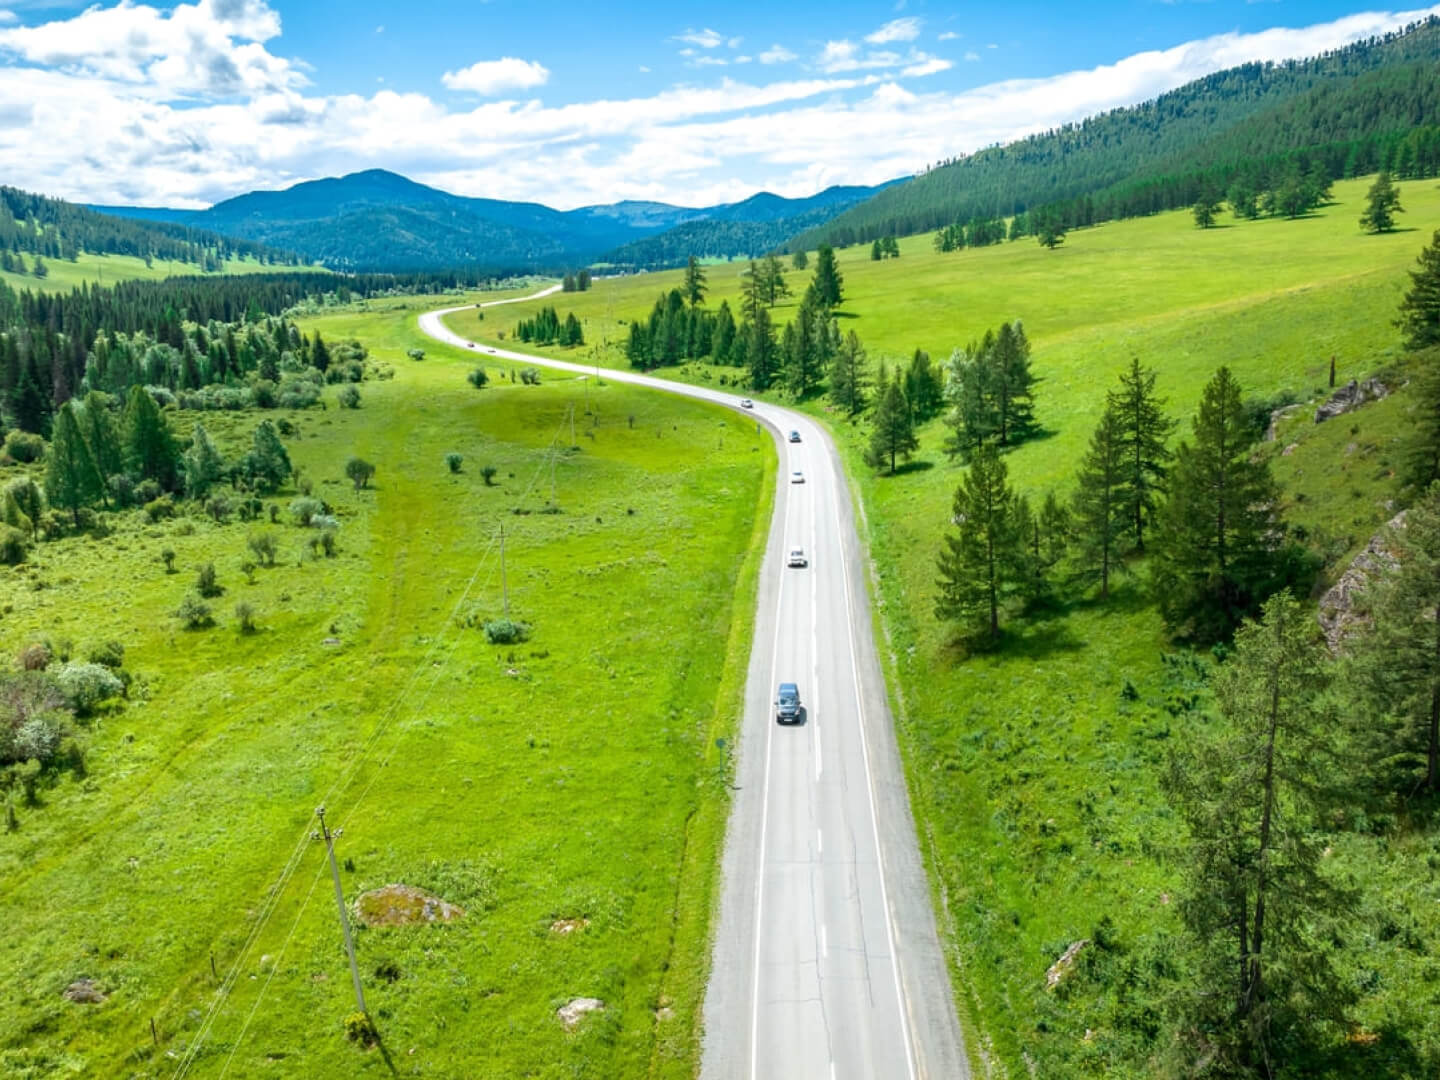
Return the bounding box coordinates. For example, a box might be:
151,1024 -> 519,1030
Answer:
0,187 -> 301,276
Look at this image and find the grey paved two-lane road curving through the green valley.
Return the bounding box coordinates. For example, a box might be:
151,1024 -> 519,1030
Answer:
420,298 -> 969,1080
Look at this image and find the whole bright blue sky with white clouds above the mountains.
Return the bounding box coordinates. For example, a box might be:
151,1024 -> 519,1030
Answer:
0,0 -> 1440,209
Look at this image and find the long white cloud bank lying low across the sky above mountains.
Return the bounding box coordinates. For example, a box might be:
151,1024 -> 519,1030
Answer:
0,0 -> 1440,213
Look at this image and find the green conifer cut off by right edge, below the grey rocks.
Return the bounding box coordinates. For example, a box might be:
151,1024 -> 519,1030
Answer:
1346,484 -> 1440,796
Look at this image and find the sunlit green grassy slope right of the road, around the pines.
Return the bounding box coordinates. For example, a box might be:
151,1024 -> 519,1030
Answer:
455,180 -> 1440,1076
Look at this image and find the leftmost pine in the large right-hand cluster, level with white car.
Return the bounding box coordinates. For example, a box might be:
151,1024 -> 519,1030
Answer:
935,446 -> 1025,641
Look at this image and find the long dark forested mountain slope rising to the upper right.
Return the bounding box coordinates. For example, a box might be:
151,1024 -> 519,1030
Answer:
788,17 -> 1440,249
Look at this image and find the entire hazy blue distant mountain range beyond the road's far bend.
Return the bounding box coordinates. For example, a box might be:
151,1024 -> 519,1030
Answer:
91,168 -> 884,274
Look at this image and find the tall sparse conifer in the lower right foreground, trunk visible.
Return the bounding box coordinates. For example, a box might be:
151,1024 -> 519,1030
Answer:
1166,592 -> 1351,1076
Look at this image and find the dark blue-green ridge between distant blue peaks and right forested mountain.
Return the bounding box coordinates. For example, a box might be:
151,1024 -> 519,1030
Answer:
603,180 -> 901,269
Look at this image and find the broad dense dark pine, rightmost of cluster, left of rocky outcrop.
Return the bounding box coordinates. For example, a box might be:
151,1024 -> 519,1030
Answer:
1153,367 -> 1282,641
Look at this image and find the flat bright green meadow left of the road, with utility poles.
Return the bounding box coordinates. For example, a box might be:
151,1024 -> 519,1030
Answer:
0,301 -> 775,1077
